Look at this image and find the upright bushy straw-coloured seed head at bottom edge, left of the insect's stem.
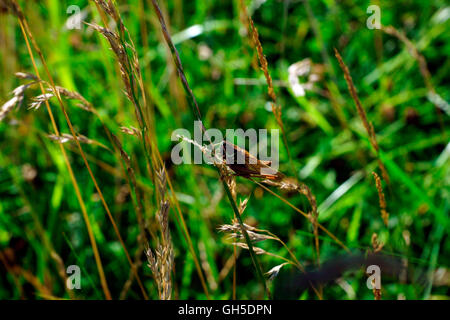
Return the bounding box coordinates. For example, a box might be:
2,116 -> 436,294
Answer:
145,168 -> 174,300
